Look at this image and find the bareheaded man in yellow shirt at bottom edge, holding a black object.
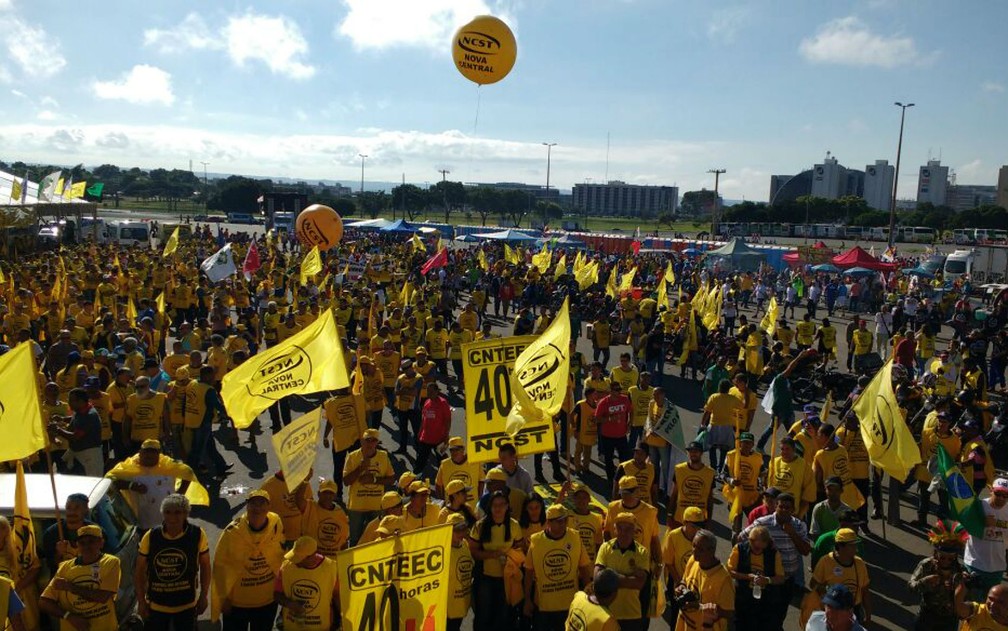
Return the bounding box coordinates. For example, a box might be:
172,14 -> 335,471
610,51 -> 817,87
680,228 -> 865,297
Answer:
675,530 -> 735,631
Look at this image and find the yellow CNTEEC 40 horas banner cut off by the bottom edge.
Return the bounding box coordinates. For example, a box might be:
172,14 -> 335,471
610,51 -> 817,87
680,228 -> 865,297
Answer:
336,524 -> 452,631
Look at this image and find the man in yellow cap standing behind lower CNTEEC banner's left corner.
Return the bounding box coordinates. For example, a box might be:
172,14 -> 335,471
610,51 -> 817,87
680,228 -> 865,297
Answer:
343,429 -> 395,545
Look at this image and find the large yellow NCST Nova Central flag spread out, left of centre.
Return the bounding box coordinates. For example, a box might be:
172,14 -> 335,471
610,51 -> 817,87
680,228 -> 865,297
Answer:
221,309 -> 350,429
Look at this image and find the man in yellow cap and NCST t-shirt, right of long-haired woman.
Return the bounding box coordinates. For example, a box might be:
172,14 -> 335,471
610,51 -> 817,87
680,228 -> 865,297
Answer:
523,504 -> 592,629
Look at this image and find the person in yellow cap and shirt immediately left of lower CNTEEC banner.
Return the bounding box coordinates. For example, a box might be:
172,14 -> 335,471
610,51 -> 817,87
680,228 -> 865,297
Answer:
274,536 -> 340,631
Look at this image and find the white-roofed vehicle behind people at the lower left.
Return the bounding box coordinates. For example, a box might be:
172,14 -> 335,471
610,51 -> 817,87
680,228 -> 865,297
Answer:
0,474 -> 140,627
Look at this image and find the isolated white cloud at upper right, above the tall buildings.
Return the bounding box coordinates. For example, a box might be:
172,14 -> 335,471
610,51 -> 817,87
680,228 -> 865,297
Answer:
798,16 -> 933,68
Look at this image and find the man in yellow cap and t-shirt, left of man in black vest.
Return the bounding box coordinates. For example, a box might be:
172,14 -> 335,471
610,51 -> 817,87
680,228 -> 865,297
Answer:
39,525 -> 121,631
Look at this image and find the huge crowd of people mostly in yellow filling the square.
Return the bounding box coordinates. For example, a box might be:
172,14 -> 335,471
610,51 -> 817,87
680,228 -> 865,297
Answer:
0,223 -> 1008,631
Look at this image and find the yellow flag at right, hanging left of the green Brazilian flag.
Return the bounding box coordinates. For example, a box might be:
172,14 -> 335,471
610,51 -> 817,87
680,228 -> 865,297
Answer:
854,359 -> 920,480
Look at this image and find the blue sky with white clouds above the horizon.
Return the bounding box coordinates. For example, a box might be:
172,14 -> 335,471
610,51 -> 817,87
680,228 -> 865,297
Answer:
0,0 -> 1008,201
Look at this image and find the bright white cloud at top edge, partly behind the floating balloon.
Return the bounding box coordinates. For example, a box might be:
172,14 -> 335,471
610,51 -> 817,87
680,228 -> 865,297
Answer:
336,0 -> 514,52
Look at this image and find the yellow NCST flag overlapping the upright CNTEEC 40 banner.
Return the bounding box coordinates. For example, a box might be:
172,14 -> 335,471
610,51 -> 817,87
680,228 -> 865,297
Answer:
506,298 -> 571,435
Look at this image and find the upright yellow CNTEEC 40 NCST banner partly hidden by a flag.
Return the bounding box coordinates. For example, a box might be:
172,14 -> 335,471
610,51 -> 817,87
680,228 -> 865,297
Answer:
462,336 -> 556,463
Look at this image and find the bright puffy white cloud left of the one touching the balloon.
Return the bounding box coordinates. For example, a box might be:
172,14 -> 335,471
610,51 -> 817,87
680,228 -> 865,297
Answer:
223,13 -> 316,79
